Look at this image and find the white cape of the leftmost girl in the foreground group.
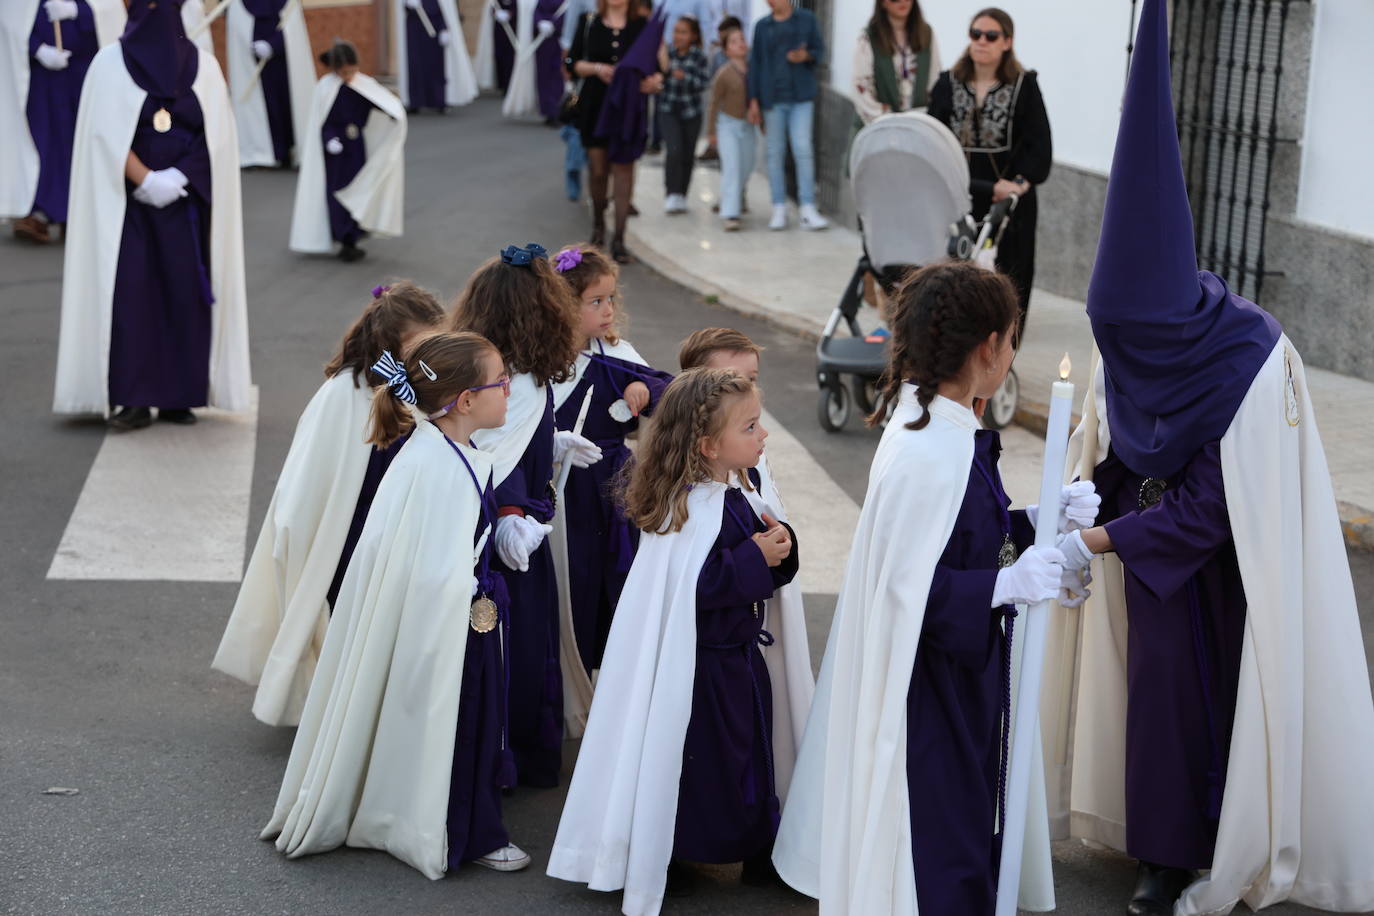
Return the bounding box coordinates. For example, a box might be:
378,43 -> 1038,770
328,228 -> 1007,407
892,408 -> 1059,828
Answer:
212,371 -> 372,725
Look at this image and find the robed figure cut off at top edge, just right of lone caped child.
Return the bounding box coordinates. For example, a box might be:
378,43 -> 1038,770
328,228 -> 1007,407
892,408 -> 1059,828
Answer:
392,0 -> 478,111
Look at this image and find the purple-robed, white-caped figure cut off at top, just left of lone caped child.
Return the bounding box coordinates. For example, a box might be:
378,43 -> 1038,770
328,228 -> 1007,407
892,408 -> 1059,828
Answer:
224,0 -> 315,169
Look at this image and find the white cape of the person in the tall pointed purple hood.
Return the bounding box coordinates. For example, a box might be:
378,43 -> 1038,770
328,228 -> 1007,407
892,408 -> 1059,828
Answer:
1051,336 -> 1374,916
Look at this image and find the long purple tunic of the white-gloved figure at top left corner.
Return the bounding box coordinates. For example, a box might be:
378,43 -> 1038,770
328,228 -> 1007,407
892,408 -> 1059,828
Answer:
25,0 -> 100,222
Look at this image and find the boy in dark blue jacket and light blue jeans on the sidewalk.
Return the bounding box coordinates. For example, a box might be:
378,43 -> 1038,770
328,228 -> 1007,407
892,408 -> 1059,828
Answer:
749,0 -> 830,229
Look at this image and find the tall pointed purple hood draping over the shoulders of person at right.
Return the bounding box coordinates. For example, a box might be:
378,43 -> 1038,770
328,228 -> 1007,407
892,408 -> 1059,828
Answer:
1087,0 -> 1281,477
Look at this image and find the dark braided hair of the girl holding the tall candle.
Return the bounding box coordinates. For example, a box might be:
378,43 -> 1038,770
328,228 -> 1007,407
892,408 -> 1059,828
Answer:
868,261 -> 1021,430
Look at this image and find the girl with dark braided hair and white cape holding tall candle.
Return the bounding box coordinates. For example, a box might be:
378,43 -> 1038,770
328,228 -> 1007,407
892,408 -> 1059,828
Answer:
774,261 -> 1096,913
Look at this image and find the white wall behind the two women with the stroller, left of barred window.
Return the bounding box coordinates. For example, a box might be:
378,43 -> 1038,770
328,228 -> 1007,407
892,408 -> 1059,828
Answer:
830,0 -> 1126,174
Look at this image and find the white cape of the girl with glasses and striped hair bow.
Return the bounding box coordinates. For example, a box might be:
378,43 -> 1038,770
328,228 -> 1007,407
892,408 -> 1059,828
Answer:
262,423 -> 491,879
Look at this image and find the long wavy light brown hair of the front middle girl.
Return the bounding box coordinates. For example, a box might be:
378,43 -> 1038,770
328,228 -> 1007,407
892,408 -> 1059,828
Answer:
621,368 -> 756,534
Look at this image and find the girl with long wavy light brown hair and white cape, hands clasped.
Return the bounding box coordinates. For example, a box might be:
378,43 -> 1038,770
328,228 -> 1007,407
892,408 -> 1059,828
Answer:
548,368 -> 811,913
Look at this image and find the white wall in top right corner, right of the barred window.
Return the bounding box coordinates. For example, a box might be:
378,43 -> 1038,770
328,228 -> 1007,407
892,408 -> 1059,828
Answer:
1297,0 -> 1374,238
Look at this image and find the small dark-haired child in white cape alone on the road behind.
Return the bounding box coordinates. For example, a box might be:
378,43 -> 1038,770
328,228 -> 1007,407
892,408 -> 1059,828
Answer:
290,41 -> 405,261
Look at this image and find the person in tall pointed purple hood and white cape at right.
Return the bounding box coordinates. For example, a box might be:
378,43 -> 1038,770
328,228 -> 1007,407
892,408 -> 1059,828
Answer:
1038,0 -> 1374,915
